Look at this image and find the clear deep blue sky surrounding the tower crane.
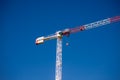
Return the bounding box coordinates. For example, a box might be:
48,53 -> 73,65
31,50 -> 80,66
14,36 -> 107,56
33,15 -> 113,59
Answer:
0,0 -> 120,80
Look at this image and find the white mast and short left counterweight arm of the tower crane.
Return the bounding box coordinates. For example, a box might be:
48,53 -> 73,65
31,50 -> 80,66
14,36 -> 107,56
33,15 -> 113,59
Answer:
36,31 -> 62,80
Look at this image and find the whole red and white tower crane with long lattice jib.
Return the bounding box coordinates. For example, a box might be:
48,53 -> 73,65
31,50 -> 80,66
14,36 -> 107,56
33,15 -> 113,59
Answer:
35,16 -> 120,80
